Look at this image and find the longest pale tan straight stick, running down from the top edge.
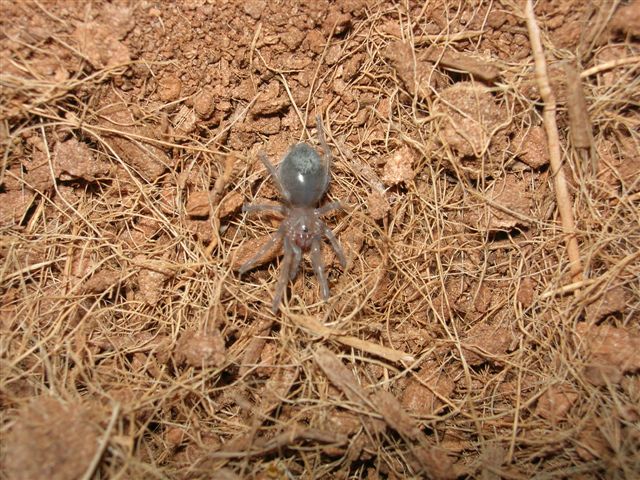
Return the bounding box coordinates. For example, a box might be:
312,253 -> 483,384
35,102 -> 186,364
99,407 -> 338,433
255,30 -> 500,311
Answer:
525,0 -> 582,284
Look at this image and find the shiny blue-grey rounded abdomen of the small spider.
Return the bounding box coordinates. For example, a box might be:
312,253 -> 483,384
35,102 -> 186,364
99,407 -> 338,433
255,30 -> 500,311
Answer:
278,143 -> 329,206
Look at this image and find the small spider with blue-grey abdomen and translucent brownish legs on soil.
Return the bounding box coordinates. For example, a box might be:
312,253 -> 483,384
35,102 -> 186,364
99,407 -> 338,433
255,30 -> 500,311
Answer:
238,116 -> 347,314
